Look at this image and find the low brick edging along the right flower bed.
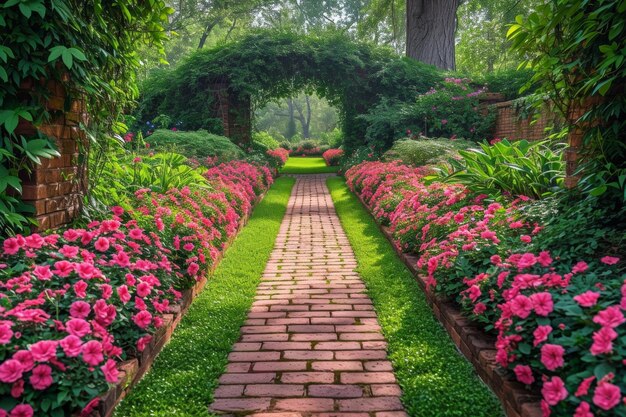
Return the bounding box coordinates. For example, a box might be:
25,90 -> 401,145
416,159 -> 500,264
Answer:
350,191 -> 542,417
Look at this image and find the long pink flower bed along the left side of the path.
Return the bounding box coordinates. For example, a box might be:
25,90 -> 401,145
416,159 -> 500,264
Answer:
0,162 -> 272,417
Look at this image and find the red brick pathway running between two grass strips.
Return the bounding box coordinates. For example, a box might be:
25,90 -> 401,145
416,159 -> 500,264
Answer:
211,175 -> 406,417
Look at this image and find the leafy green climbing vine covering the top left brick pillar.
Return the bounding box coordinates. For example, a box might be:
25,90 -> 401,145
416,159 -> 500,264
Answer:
0,0 -> 171,234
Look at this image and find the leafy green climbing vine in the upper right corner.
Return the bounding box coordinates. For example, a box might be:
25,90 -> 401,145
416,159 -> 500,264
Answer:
508,0 -> 626,201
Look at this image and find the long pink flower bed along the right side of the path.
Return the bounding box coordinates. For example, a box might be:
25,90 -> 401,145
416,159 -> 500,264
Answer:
346,162 -> 626,417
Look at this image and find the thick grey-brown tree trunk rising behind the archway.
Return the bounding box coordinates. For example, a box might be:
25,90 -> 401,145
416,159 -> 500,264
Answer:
406,0 -> 460,70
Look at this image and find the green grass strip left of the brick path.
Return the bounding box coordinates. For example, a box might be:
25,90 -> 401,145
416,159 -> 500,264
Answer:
114,178 -> 295,417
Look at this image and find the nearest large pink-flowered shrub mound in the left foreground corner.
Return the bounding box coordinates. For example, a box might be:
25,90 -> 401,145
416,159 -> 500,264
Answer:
0,221 -> 179,415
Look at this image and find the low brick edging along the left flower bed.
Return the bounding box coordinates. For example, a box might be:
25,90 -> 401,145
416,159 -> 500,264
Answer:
91,187 -> 271,417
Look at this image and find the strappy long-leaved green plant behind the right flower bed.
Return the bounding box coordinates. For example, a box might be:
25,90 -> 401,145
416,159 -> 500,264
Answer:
440,140 -> 565,198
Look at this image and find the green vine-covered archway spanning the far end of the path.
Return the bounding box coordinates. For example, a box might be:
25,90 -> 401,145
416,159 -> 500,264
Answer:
139,31 -> 442,149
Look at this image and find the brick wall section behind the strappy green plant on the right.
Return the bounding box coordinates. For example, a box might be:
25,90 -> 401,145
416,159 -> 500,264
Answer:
494,101 -> 555,140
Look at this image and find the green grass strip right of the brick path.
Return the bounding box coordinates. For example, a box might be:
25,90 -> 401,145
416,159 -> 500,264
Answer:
327,177 -> 503,417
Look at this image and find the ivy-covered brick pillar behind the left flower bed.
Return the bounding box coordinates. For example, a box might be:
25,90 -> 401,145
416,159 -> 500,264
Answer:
16,81 -> 87,230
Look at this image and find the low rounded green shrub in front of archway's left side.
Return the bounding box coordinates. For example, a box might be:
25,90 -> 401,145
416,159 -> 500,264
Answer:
146,129 -> 244,162
